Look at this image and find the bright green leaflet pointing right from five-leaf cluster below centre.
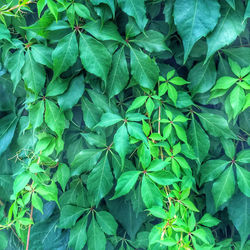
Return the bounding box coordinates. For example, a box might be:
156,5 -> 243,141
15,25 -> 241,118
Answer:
147,171 -> 179,186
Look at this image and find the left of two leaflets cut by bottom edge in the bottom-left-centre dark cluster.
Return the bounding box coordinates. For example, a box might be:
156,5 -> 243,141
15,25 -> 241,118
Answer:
69,216 -> 88,250
